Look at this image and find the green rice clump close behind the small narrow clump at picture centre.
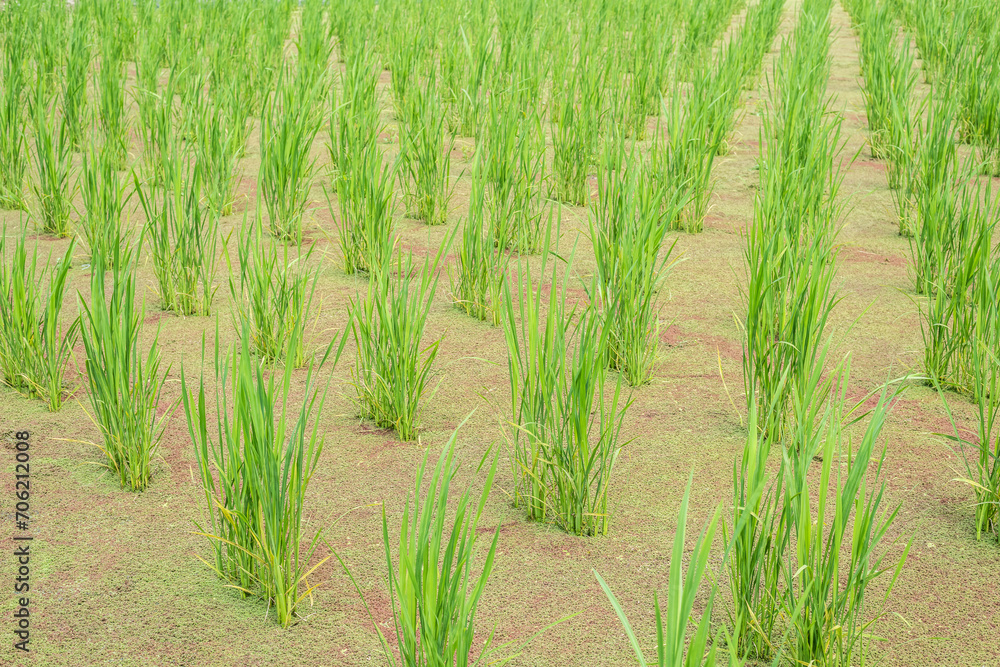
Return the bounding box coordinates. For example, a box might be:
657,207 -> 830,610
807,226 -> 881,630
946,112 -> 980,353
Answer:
481,97 -> 550,254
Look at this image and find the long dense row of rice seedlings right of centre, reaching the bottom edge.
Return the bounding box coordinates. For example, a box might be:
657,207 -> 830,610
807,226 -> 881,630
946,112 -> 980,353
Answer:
725,0 -> 906,665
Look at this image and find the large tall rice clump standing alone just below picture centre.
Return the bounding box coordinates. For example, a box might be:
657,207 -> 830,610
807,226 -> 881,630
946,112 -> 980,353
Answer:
503,240 -> 631,535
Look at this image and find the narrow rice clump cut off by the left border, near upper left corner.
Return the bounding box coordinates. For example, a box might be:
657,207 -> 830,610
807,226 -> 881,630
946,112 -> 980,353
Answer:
0,15 -> 28,211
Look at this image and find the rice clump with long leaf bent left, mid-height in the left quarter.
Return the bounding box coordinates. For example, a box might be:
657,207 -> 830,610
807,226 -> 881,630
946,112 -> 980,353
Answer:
133,149 -> 219,315
